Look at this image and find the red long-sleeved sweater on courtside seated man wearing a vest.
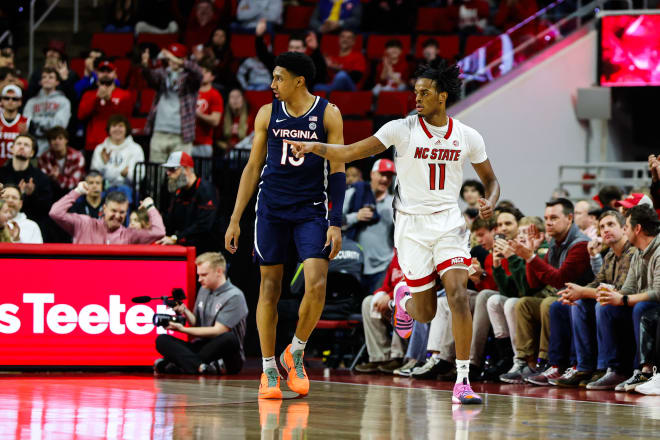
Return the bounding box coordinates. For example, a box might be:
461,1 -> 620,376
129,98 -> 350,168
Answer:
525,241 -> 591,289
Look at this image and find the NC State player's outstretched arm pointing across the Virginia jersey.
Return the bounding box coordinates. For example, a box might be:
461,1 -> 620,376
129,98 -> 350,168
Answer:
287,136 -> 387,163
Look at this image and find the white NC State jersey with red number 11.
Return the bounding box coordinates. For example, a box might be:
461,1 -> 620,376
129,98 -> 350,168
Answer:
374,115 -> 488,215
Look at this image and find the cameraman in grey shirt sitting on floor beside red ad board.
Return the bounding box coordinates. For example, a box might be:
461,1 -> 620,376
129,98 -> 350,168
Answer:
154,252 -> 248,374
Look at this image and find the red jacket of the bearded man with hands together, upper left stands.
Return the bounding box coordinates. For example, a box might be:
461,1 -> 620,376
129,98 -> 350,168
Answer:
78,87 -> 133,151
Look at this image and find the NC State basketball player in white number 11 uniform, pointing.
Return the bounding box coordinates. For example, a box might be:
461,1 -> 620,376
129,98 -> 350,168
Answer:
287,60 -> 500,404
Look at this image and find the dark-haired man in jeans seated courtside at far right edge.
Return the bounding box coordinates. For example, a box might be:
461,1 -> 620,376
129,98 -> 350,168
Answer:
598,205 -> 660,391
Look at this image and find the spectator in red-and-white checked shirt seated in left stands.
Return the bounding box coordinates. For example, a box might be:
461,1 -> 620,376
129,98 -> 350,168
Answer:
39,127 -> 85,198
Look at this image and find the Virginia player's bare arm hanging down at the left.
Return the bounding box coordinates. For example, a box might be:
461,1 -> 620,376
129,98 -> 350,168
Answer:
225,104 -> 272,254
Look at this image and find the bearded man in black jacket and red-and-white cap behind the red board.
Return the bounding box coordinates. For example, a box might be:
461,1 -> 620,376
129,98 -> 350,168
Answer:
157,151 -> 219,255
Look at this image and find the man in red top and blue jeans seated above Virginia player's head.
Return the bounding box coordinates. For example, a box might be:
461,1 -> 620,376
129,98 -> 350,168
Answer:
314,29 -> 367,93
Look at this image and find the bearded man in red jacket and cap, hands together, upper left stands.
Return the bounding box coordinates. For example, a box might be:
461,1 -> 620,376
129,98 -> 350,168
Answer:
78,60 -> 133,151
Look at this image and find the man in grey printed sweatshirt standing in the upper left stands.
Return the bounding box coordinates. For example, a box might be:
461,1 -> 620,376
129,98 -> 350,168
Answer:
23,67 -> 71,156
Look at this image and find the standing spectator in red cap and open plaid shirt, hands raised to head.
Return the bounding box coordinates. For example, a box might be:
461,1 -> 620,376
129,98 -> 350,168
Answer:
142,43 -> 203,163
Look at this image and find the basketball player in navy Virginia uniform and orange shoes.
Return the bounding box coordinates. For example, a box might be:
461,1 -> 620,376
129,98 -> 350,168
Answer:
225,52 -> 346,399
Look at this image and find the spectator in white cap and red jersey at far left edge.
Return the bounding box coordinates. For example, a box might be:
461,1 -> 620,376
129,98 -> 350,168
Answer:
0,84 -> 30,167
